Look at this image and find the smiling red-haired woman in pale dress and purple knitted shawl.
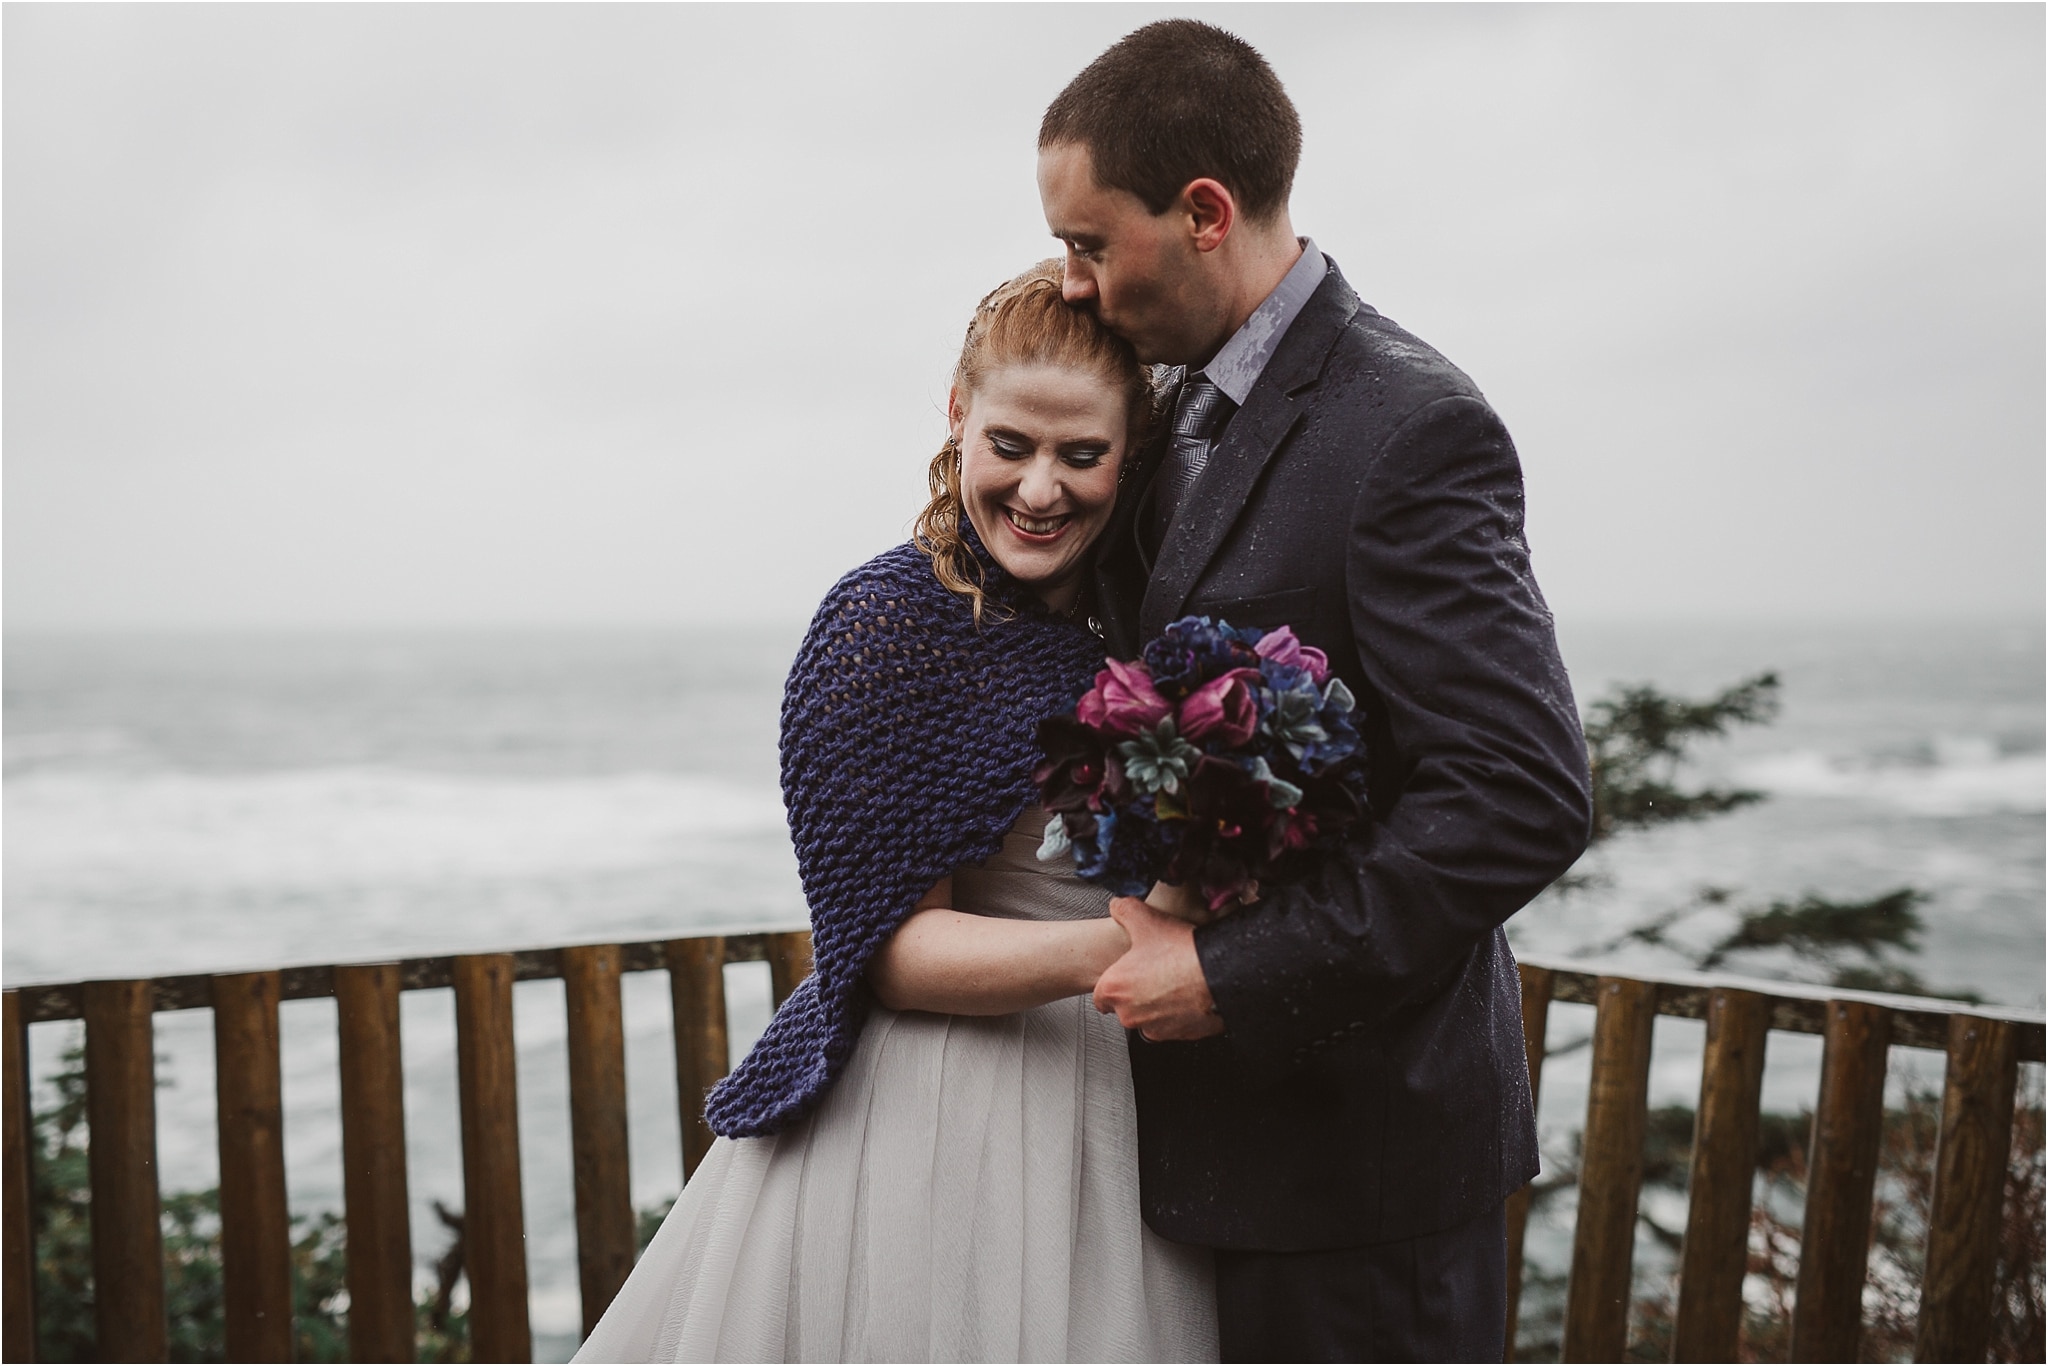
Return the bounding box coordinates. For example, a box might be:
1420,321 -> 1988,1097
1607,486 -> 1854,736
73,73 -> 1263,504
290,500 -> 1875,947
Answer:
575,262 -> 1217,1362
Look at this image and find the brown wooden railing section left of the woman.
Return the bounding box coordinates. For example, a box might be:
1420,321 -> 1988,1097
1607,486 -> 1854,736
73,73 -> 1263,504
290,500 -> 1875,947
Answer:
0,932 -> 811,1362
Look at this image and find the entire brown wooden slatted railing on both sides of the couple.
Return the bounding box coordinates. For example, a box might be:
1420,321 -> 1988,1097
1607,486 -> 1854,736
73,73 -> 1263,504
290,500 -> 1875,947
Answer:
0,946 -> 2044,1362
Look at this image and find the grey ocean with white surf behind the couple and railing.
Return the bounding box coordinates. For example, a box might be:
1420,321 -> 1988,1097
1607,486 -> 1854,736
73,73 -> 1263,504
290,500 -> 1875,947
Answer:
0,621 -> 2048,1360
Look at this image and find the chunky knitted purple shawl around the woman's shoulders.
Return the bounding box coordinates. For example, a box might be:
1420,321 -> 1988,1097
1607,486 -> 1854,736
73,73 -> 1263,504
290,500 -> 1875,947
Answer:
705,532 -> 1102,1139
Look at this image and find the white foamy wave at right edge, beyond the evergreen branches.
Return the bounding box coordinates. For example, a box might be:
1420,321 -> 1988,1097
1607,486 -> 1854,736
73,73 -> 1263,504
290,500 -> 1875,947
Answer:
1735,737 -> 2048,815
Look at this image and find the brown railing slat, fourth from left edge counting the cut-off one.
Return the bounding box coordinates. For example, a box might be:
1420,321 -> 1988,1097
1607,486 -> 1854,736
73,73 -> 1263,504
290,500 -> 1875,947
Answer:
334,963 -> 414,1362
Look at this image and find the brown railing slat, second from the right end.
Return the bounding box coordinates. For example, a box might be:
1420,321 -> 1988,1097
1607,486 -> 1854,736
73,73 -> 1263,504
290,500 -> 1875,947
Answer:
1792,1001 -> 1892,1362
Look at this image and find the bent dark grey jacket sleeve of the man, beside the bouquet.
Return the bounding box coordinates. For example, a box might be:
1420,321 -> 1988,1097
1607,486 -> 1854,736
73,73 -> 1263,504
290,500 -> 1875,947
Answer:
1196,395 -> 1591,1069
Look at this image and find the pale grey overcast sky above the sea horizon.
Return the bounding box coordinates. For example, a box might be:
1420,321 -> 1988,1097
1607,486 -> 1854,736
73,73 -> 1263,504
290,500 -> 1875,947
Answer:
0,4 -> 2048,627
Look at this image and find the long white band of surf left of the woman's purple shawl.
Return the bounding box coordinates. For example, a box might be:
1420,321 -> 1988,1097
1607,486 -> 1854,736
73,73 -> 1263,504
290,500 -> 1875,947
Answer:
4,768 -> 784,891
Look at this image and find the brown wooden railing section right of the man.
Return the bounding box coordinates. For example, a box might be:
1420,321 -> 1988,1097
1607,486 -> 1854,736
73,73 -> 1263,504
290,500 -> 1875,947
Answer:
1507,961 -> 2044,1362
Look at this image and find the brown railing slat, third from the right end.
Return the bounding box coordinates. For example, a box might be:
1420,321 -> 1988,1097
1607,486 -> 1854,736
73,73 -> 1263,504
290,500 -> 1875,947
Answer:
1673,987 -> 1772,1362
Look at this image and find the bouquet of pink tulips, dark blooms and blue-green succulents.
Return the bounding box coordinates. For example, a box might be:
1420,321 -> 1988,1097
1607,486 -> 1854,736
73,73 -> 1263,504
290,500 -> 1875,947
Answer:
1032,616 -> 1364,915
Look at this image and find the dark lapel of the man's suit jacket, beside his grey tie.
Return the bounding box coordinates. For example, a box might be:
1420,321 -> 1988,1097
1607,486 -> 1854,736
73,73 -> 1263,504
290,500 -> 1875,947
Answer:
1133,274 -> 1358,641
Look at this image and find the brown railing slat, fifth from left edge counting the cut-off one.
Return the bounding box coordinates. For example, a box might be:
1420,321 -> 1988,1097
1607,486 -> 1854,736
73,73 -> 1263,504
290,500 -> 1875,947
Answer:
453,954 -> 532,1362
